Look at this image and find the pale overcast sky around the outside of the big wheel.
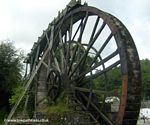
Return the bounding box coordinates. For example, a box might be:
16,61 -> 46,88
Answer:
0,0 -> 150,59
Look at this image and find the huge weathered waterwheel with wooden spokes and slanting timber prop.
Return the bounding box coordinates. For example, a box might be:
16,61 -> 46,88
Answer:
5,1 -> 141,125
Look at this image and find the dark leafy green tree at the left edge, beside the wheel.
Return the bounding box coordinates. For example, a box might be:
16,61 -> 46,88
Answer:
0,41 -> 23,122
